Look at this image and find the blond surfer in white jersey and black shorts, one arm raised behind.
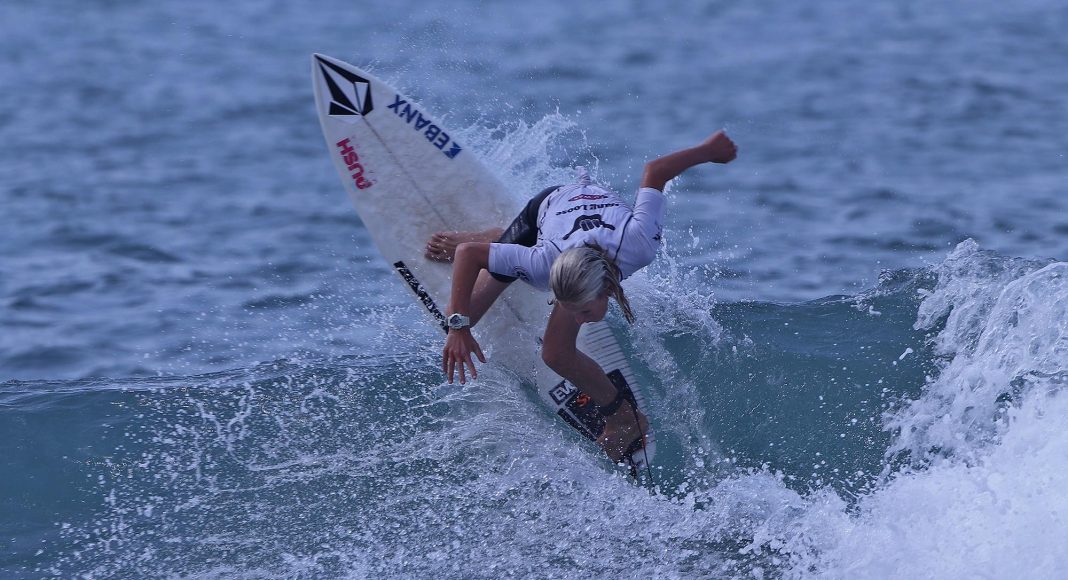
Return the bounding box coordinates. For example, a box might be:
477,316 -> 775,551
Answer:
426,130 -> 737,461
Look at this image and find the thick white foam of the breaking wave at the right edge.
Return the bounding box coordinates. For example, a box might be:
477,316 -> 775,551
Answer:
777,241 -> 1068,578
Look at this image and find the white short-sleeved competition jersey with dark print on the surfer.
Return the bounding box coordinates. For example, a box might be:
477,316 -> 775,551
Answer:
489,168 -> 664,291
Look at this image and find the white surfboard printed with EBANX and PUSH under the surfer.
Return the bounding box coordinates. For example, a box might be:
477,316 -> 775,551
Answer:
312,54 -> 656,468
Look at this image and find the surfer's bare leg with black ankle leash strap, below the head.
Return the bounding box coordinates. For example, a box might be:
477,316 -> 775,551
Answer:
541,304 -> 649,461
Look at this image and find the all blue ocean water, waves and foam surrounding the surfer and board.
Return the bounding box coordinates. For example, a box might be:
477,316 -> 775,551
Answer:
0,0 -> 1068,579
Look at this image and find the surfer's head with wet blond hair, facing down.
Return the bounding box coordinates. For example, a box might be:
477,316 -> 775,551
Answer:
549,246 -> 634,324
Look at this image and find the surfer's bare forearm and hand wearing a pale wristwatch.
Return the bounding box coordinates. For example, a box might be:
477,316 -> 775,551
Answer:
441,241 -> 489,385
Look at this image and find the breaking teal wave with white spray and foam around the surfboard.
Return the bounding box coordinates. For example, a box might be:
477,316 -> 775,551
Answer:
5,115 -> 1068,578
